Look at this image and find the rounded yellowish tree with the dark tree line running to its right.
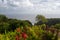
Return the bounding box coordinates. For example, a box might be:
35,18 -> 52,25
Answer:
35,15 -> 60,26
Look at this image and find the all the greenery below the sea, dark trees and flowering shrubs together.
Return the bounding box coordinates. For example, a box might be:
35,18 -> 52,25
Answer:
0,15 -> 60,40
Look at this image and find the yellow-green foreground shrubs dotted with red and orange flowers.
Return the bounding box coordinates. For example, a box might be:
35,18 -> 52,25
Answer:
0,25 -> 56,40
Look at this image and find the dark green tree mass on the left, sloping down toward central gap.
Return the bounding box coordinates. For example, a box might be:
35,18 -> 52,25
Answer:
0,15 -> 32,33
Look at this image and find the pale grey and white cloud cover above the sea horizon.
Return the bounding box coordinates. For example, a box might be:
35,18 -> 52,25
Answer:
0,0 -> 60,14
